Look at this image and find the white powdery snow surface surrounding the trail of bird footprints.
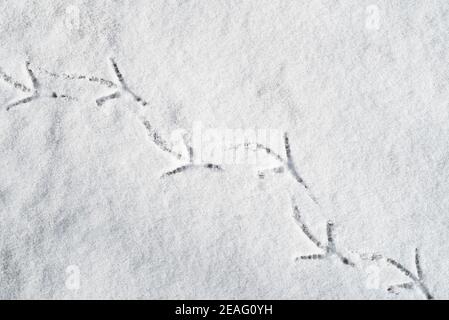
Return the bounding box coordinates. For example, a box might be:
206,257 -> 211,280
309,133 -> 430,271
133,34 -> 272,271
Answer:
0,0 -> 449,299
